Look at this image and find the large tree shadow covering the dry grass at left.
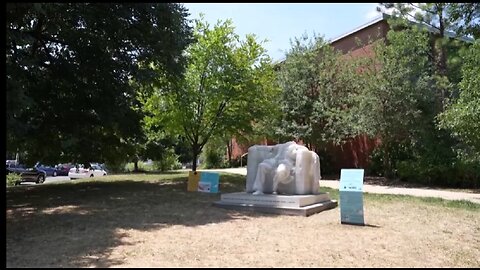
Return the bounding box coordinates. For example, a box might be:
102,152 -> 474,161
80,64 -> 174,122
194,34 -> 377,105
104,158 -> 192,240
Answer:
6,173 -> 267,267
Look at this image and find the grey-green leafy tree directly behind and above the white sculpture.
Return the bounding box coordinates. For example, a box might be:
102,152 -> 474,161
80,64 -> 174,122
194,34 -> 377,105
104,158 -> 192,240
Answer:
278,35 -> 356,149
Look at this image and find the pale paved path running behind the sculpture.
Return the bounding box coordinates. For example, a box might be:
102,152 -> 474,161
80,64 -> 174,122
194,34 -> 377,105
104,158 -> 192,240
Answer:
198,168 -> 480,204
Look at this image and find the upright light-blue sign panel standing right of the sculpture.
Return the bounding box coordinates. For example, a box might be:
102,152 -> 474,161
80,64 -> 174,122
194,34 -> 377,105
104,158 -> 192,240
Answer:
339,169 -> 365,225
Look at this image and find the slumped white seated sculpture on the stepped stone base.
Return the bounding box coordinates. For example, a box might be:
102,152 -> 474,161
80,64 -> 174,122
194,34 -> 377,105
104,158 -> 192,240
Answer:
246,141 -> 320,195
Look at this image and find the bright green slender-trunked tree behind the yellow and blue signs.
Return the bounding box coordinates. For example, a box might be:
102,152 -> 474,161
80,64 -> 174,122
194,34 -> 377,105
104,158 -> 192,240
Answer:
143,17 -> 275,171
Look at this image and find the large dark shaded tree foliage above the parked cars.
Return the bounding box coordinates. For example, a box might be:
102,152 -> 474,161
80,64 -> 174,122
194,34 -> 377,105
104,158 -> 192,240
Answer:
6,3 -> 191,166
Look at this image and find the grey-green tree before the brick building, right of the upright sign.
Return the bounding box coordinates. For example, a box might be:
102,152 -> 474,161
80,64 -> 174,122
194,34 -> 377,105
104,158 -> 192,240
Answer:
356,29 -> 433,177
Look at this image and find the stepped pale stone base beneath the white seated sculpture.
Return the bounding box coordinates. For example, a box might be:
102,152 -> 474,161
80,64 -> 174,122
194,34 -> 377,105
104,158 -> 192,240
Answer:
213,192 -> 338,216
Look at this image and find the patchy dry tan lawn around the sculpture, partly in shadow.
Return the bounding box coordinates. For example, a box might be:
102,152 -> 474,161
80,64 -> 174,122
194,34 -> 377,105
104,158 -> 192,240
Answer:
6,173 -> 480,267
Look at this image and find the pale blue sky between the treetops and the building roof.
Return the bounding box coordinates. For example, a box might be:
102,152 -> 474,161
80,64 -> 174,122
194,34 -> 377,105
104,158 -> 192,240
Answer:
184,3 -> 380,61
